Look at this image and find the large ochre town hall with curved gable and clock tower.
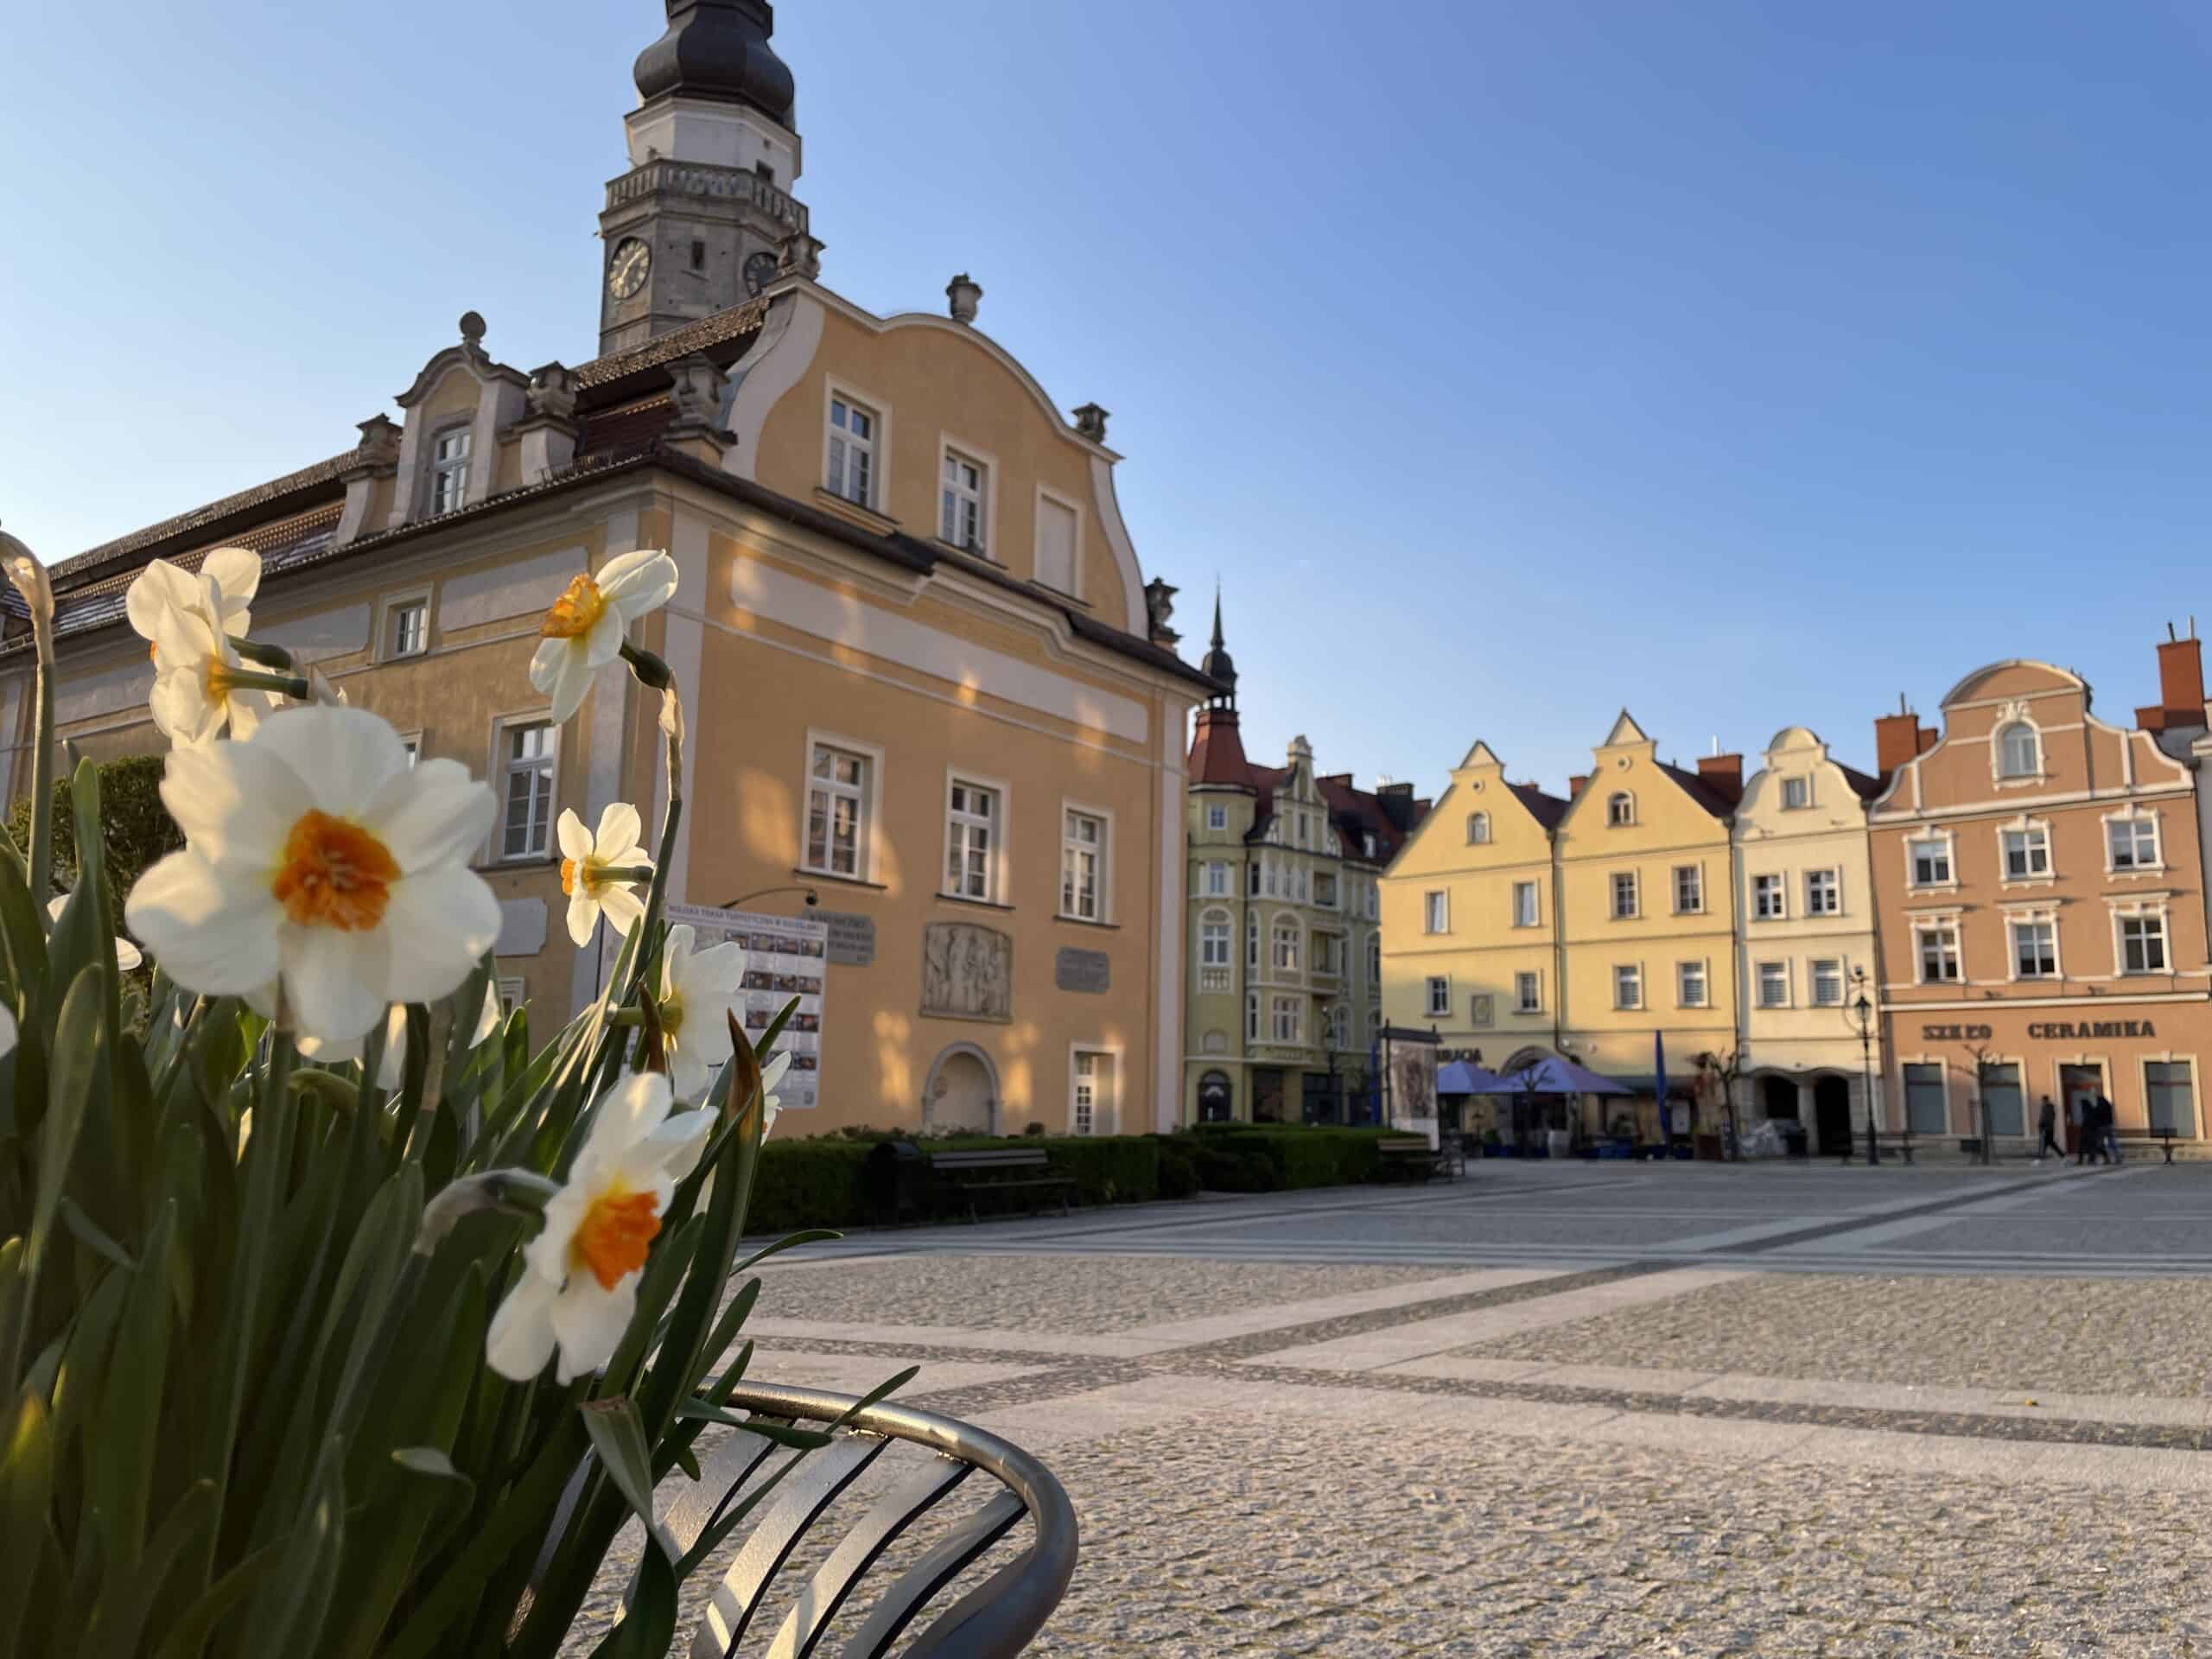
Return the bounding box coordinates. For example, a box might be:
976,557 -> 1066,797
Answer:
0,0 -> 1214,1133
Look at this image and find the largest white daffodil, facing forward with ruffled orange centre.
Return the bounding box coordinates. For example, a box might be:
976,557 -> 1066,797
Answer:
124,706 -> 500,1042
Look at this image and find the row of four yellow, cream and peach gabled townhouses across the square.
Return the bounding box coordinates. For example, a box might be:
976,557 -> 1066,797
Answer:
1380,631 -> 2212,1153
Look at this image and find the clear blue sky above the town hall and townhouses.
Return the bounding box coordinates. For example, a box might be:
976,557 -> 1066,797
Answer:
0,0 -> 2212,787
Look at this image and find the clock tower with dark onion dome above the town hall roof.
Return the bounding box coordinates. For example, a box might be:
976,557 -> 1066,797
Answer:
600,0 -> 807,354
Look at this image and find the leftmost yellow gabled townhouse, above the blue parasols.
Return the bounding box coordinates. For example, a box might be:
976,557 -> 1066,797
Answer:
1382,741 -> 1568,1066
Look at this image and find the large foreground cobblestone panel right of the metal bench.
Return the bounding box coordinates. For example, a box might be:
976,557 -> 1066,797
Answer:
1031,1418 -> 2212,1659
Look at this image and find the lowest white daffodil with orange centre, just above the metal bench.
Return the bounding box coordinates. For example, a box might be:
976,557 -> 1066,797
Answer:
485,1073 -> 715,1385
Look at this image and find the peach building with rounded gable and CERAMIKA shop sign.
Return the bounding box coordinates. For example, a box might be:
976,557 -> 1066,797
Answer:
1869,639 -> 2212,1150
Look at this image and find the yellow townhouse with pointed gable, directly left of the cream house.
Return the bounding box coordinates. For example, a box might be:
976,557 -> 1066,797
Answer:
1557,710 -> 1741,1089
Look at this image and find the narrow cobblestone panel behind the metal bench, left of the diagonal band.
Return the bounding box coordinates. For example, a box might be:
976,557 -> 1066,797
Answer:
759,1255 -> 1438,1334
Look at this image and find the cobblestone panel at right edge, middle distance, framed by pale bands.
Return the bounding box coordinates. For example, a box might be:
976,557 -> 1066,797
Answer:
1469,1274 -> 2212,1398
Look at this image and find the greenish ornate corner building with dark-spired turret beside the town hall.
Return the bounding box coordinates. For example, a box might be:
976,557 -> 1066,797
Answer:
1184,600 -> 1429,1123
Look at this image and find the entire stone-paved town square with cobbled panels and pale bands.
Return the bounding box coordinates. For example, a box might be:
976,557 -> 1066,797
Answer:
557,1161 -> 2212,1659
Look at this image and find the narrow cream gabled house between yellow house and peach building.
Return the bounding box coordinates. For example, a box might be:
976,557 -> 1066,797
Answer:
1734,726 -> 1883,1154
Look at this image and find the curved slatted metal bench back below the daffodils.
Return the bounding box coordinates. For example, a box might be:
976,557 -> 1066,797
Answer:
668,1385 -> 1077,1659
